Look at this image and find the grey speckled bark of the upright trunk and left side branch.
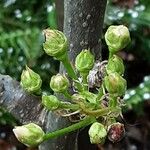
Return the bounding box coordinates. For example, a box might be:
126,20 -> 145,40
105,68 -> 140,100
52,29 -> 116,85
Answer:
0,0 -> 106,150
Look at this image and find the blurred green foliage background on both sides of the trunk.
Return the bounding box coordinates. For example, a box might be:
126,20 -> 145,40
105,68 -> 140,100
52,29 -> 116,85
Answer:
0,0 -> 150,124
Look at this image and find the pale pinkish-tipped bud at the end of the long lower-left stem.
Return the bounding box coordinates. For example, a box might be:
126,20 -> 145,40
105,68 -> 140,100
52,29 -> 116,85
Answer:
13,123 -> 45,147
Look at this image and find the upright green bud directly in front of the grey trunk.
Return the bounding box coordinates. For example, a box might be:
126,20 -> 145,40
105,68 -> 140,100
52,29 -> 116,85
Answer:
75,50 -> 94,73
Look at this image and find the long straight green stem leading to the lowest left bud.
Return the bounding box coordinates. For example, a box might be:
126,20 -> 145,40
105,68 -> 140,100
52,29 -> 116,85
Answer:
43,117 -> 96,141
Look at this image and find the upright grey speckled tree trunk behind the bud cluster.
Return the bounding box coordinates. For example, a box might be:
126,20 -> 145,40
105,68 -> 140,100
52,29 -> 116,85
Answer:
40,0 -> 107,150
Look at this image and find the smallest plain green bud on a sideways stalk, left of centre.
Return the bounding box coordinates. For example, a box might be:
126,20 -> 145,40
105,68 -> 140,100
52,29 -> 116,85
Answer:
42,95 -> 60,110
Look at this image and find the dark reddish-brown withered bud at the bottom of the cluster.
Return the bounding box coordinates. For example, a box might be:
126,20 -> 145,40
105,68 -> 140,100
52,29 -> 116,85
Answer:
108,122 -> 125,143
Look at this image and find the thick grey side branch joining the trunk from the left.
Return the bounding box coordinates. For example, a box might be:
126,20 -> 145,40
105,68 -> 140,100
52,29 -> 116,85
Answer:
0,75 -> 47,127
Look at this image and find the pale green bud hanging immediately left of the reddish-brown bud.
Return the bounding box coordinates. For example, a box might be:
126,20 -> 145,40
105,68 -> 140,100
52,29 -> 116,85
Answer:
89,122 -> 107,144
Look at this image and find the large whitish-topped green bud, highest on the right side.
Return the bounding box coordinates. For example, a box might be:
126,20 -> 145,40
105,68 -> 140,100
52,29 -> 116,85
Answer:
105,25 -> 131,53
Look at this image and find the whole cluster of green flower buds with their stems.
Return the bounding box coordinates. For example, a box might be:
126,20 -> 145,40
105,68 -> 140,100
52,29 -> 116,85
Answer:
14,25 -> 130,146
